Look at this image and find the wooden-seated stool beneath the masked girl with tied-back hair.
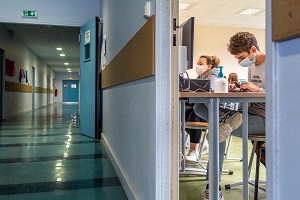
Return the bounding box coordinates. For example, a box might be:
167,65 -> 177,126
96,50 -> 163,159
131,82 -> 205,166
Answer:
185,122 -> 233,175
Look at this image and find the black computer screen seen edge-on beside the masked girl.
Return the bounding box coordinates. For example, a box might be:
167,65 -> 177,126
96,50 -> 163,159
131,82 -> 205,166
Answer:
179,17 -> 195,69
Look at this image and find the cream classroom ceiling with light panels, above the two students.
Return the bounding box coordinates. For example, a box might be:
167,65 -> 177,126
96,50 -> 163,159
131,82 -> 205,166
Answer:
179,0 -> 266,29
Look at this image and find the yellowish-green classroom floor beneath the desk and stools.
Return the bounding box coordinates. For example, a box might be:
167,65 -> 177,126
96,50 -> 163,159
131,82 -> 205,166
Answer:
179,137 -> 266,200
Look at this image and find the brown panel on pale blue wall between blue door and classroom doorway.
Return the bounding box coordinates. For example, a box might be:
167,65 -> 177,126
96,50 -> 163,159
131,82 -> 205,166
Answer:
101,16 -> 155,89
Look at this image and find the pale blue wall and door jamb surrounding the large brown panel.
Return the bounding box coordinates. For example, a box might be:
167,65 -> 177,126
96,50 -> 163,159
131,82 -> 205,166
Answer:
102,0 -> 171,200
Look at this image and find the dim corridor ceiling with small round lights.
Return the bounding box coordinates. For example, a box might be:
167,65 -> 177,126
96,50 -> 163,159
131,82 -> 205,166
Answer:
4,23 -> 80,72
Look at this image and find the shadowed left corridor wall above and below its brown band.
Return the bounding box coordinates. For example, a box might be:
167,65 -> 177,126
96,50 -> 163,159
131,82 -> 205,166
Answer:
0,25 -> 54,119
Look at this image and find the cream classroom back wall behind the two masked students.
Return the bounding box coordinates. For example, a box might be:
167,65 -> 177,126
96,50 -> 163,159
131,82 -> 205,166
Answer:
189,25 -> 266,79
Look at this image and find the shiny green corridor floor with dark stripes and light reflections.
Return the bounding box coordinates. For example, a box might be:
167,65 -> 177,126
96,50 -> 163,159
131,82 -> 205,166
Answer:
0,103 -> 127,200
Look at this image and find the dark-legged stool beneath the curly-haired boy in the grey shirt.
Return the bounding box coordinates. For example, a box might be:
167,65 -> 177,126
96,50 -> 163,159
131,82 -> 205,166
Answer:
225,134 -> 266,200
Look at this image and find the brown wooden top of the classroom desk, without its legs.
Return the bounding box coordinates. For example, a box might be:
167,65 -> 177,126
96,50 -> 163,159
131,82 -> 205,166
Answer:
179,92 -> 266,98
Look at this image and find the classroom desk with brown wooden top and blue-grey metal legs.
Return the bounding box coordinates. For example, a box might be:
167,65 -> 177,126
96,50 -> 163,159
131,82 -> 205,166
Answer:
179,92 -> 265,200
